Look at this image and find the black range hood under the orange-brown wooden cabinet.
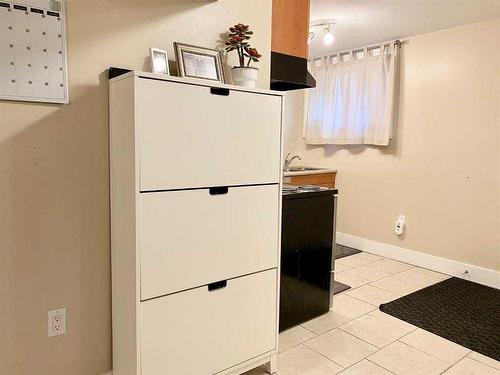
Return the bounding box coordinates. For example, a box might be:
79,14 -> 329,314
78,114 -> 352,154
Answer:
271,51 -> 316,91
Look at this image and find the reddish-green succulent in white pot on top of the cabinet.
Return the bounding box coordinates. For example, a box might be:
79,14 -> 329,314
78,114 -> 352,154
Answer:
226,23 -> 262,87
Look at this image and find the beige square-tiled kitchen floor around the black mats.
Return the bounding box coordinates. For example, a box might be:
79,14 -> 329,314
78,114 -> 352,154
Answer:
246,253 -> 500,375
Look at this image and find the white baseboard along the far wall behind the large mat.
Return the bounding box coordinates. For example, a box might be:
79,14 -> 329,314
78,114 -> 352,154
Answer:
337,232 -> 500,289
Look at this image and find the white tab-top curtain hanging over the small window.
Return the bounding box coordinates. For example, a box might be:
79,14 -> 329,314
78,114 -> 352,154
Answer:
305,44 -> 399,146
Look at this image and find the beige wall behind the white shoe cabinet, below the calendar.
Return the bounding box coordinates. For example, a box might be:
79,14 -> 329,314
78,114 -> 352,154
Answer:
0,0 -> 271,375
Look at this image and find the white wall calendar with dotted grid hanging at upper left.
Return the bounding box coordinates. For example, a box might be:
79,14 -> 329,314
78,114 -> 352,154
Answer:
0,0 -> 68,103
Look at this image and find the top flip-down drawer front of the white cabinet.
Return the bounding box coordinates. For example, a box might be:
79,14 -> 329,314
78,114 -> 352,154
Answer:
136,78 -> 281,191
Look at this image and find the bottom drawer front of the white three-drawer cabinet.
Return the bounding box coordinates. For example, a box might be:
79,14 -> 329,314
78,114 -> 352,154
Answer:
141,269 -> 277,375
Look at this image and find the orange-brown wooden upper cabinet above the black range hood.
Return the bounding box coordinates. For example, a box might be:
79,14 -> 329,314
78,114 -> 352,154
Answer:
271,0 -> 309,59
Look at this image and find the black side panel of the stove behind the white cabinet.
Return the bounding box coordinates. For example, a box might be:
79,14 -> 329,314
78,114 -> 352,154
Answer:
279,190 -> 336,332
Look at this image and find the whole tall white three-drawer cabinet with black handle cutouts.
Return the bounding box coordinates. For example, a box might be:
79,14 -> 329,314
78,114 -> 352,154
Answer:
109,72 -> 283,375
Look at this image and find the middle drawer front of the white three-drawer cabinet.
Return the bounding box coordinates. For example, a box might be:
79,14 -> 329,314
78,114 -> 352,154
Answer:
140,185 -> 280,300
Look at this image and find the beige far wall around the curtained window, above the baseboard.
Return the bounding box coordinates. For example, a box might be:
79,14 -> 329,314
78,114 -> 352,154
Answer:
285,20 -> 500,270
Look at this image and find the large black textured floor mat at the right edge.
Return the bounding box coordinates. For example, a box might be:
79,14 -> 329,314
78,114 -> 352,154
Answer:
380,277 -> 500,361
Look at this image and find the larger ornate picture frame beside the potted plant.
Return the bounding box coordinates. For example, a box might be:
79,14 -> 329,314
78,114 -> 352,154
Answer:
174,42 -> 225,83
